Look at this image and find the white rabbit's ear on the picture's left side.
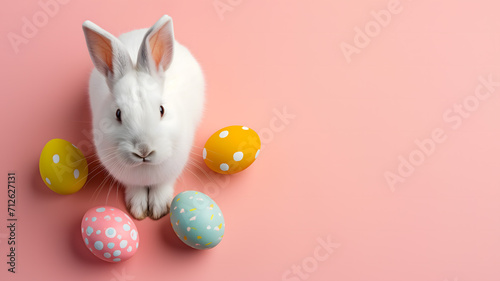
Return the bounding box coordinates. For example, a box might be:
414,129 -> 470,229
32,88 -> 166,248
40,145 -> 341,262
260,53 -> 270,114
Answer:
83,20 -> 132,80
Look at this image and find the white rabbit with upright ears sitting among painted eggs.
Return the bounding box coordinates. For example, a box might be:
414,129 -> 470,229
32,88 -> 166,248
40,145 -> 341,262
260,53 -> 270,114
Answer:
83,15 -> 205,219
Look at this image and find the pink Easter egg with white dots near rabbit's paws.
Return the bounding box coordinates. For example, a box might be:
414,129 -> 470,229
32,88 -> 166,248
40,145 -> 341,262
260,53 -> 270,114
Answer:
81,206 -> 139,262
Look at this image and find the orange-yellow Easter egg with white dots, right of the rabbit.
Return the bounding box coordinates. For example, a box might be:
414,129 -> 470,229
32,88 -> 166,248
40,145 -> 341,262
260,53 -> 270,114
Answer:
203,126 -> 260,174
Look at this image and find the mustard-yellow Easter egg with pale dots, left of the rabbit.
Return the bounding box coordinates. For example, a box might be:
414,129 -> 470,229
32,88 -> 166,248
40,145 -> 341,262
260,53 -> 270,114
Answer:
38,139 -> 88,194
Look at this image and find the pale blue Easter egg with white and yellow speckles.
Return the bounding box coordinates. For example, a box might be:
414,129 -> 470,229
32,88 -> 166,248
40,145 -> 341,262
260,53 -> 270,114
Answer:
170,191 -> 226,250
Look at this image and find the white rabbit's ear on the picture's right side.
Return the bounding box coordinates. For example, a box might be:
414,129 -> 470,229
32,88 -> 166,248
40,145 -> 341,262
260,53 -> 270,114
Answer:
137,15 -> 174,74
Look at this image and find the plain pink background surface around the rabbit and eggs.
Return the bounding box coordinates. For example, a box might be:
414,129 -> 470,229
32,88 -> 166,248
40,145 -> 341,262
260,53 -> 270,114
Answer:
0,0 -> 500,281
